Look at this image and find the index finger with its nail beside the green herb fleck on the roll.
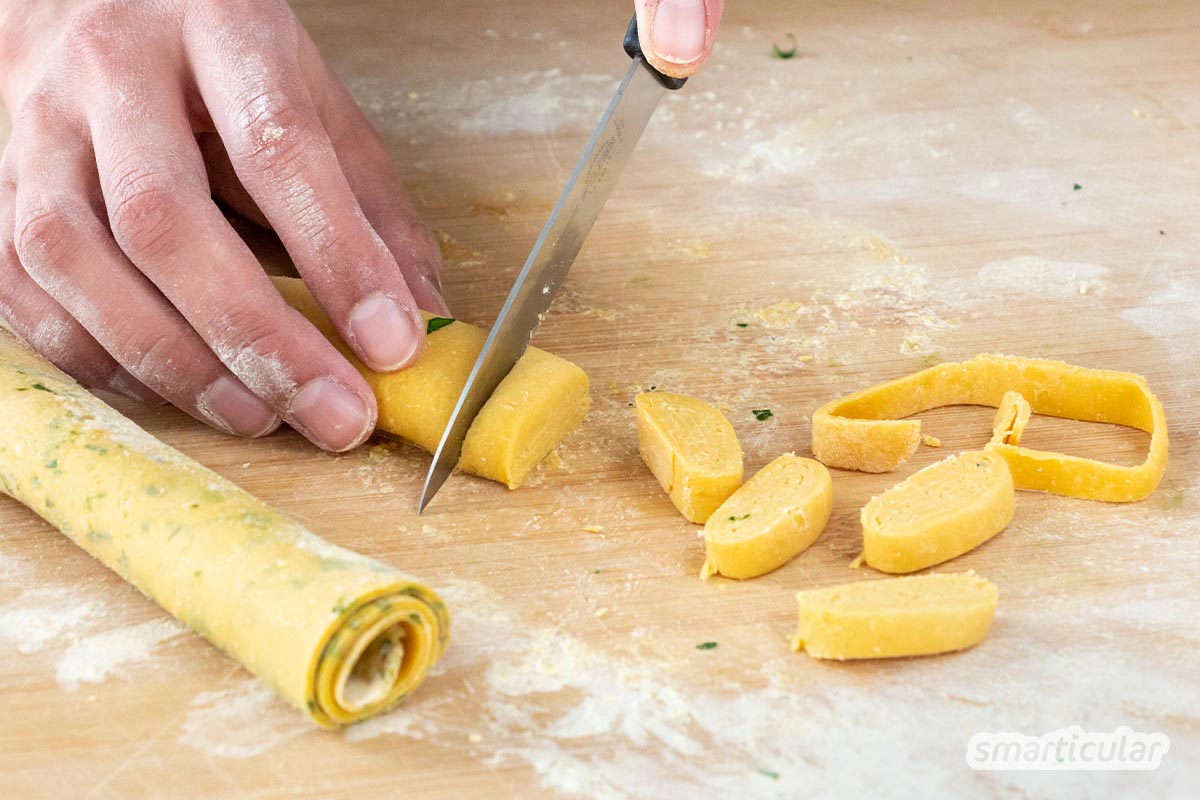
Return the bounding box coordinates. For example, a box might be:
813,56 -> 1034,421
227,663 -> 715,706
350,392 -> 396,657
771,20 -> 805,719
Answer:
186,8 -> 434,371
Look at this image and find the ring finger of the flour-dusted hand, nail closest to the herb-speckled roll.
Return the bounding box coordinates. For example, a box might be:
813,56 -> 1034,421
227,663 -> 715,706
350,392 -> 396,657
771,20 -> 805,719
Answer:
13,115 -> 278,435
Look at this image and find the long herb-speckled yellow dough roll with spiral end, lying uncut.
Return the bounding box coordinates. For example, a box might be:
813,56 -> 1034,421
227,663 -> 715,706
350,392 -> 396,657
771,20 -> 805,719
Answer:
0,329 -> 450,726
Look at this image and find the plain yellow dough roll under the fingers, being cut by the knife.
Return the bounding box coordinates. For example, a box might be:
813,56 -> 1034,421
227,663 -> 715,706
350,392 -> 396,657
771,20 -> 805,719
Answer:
272,278 -> 592,489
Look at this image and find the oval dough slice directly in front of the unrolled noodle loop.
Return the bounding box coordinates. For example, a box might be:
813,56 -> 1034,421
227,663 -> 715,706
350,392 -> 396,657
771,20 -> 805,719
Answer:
862,451 -> 1015,572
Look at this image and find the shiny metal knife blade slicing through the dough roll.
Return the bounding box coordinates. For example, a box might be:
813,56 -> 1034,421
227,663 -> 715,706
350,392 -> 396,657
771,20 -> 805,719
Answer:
418,58 -> 666,513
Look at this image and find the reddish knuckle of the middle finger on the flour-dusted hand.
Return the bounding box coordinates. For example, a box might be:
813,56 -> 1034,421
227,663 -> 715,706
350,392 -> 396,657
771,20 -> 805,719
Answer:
108,167 -> 181,258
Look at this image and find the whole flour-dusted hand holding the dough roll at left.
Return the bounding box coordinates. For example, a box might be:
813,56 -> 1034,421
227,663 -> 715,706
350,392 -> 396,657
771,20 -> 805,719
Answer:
0,0 -> 446,450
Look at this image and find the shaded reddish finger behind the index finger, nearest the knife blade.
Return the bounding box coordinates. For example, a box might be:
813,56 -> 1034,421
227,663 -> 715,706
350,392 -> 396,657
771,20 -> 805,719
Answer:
300,31 -> 450,315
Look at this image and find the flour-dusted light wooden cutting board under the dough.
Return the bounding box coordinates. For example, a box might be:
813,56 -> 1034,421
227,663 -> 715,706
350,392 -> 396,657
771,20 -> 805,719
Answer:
0,0 -> 1200,798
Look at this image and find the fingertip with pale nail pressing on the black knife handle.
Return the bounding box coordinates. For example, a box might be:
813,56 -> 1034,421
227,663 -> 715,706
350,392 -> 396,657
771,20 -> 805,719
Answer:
634,0 -> 725,78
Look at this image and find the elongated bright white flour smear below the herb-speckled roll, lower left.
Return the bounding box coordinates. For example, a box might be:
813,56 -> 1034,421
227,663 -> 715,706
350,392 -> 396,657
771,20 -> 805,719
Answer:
55,619 -> 187,692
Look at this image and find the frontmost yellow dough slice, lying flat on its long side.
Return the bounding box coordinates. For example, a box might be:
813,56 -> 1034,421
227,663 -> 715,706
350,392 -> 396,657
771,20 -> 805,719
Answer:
792,572 -> 1000,661
